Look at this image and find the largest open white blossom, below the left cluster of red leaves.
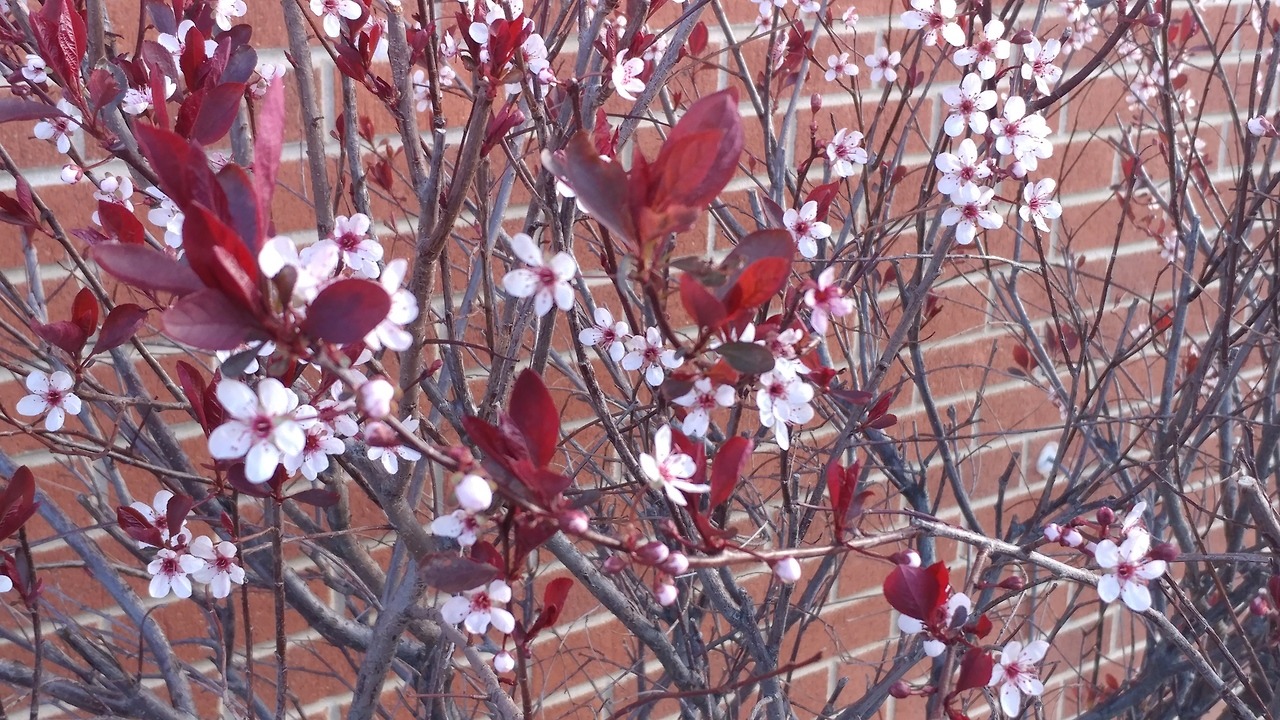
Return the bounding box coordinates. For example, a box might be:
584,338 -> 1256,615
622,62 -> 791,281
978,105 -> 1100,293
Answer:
209,378 -> 314,483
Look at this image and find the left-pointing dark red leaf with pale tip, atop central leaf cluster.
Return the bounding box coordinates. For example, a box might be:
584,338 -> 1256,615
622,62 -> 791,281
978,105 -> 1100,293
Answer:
543,131 -> 640,243
